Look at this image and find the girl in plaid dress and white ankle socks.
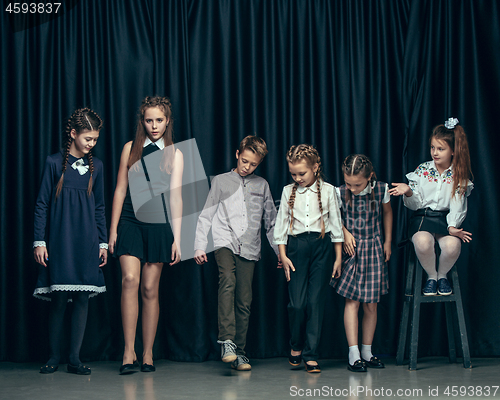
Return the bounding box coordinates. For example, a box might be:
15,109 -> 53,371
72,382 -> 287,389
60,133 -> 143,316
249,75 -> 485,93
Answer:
331,154 -> 392,372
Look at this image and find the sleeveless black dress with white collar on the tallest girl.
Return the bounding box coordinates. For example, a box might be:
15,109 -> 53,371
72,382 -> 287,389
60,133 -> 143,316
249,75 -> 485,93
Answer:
114,143 -> 174,263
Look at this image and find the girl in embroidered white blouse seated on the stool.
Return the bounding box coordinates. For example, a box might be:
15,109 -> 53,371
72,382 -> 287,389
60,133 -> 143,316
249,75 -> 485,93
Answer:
389,118 -> 474,296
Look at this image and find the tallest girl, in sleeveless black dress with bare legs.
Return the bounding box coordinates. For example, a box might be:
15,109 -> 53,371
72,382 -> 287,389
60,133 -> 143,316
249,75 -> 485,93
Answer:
109,97 -> 184,374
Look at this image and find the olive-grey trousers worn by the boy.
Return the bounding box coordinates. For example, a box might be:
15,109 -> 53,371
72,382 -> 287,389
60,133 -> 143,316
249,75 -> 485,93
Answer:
214,247 -> 255,355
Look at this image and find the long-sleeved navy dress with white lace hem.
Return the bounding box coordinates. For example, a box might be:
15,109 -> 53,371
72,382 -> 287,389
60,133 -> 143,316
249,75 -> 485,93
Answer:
33,152 -> 108,300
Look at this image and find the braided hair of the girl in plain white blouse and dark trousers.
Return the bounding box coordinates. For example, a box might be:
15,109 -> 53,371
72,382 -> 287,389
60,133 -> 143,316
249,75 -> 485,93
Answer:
286,144 -> 325,238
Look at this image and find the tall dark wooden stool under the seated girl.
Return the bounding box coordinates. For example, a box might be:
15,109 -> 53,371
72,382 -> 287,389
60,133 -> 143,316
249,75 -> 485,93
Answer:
396,242 -> 472,371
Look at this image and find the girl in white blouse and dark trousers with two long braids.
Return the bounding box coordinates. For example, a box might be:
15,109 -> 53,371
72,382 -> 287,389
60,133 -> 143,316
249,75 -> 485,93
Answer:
274,144 -> 344,373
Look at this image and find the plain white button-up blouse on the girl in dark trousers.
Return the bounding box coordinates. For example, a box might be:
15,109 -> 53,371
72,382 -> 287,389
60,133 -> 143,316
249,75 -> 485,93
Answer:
273,181 -> 344,244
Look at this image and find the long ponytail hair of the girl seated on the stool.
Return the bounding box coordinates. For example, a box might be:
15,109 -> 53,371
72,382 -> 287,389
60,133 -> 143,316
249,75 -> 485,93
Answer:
429,125 -> 472,194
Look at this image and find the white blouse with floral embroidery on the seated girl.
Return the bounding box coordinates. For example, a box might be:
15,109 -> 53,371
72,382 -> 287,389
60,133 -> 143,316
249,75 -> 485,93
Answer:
403,161 -> 474,228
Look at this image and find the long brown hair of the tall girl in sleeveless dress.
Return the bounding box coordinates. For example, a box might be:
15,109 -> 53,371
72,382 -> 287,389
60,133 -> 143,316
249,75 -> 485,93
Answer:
128,96 -> 175,173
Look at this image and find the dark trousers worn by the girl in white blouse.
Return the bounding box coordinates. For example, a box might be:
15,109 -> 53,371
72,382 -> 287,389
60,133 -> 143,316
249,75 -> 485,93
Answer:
287,232 -> 333,361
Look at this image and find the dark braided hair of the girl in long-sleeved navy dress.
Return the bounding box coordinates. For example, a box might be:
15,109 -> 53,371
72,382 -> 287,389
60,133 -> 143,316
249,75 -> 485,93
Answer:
56,108 -> 102,199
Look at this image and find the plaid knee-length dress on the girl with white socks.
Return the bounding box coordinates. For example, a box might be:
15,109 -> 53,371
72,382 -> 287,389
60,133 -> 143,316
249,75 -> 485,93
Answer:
332,182 -> 389,303
